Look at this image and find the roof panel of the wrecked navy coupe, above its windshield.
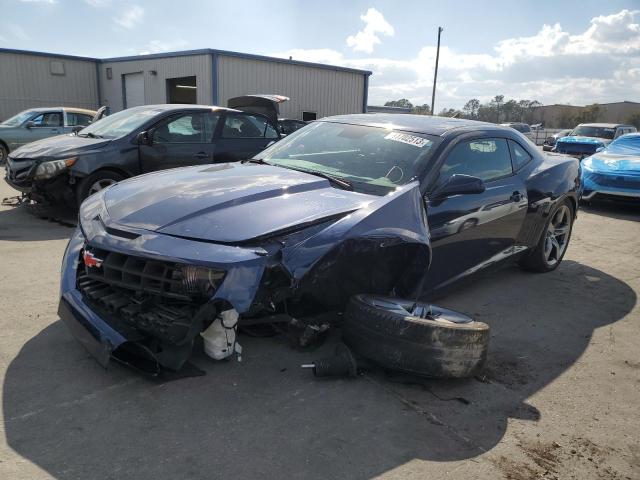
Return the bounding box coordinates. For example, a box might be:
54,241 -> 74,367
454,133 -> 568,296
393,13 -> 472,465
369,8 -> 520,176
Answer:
319,113 -> 498,136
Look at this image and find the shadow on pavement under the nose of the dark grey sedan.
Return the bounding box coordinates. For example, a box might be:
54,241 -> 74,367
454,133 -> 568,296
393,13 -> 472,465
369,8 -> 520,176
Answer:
0,205 -> 75,242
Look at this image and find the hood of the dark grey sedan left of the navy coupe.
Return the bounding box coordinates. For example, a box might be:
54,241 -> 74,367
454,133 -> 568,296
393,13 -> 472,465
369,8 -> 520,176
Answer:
11,135 -> 111,160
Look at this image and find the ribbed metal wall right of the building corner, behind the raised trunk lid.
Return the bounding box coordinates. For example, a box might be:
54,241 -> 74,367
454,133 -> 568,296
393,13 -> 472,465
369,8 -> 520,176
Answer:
218,55 -> 364,119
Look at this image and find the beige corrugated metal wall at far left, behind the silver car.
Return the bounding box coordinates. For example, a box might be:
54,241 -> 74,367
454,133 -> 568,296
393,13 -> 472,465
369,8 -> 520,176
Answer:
0,52 -> 98,121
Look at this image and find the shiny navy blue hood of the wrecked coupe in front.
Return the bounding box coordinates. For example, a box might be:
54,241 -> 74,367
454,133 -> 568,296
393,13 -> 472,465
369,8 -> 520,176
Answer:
103,164 -> 379,243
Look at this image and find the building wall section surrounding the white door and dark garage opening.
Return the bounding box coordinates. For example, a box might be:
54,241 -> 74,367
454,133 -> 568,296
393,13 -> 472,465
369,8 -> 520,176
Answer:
100,54 -> 212,113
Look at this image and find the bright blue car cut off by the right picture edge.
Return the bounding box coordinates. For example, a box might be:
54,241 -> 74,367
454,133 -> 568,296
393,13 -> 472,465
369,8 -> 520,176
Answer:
582,133 -> 640,200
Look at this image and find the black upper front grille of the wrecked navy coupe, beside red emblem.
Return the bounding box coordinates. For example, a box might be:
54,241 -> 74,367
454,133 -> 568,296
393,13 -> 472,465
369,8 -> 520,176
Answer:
81,248 -> 191,301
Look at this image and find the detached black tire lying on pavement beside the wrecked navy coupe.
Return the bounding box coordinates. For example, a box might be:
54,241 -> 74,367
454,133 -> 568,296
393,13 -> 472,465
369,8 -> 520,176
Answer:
342,295 -> 489,378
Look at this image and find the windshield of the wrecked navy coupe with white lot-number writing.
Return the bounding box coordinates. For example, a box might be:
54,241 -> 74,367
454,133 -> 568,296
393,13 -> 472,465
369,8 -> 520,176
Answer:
256,122 -> 436,194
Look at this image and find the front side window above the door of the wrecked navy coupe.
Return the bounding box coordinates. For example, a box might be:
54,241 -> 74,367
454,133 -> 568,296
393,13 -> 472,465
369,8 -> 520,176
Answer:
438,138 -> 513,185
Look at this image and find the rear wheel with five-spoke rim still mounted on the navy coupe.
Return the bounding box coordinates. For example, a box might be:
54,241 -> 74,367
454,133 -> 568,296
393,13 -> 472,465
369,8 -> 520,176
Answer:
520,200 -> 574,273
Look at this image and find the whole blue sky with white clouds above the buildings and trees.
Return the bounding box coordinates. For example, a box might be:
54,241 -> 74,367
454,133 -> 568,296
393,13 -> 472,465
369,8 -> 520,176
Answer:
0,0 -> 640,111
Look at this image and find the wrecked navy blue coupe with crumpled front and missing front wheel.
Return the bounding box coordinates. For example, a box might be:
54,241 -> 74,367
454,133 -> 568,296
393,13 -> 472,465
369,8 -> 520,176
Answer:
59,114 -> 580,370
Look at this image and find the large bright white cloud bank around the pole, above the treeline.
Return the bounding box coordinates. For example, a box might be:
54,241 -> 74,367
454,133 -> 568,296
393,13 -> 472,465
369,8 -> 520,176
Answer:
276,10 -> 640,110
